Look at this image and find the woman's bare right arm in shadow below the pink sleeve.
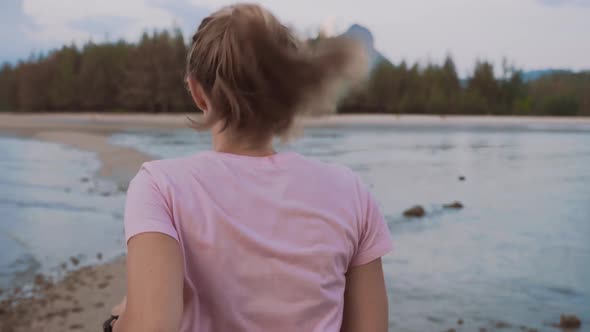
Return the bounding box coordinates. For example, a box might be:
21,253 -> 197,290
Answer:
341,258 -> 389,332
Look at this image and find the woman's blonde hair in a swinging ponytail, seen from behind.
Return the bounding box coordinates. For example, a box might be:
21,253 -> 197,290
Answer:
186,4 -> 368,141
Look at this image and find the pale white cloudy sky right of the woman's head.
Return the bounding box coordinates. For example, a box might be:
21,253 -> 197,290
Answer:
187,0 -> 590,73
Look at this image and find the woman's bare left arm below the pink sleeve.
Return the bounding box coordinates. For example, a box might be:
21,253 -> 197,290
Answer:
114,233 -> 184,332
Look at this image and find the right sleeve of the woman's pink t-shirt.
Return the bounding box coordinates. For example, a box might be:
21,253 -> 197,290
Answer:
350,176 -> 393,267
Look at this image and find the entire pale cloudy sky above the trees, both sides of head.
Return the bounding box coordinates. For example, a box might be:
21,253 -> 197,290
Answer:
0,0 -> 590,75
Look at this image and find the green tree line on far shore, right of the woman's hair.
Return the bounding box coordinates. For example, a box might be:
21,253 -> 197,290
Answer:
340,57 -> 590,116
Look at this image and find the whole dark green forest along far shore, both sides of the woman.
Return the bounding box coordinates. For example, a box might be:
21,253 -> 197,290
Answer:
0,29 -> 590,116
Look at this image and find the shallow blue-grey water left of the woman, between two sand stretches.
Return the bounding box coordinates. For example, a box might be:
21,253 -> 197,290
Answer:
0,137 -> 125,288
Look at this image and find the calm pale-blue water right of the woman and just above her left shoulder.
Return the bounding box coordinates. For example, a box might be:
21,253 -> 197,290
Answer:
112,124 -> 590,332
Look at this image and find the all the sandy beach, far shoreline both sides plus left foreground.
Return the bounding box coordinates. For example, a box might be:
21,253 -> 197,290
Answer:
0,114 -> 590,332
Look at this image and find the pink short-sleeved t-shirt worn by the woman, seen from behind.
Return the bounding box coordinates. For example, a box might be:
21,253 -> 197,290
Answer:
125,152 -> 392,332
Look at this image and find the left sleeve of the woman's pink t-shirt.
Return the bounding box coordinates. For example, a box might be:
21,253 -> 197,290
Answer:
125,165 -> 178,241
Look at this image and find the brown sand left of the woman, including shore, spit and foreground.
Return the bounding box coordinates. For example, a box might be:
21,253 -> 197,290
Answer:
0,115 -> 166,332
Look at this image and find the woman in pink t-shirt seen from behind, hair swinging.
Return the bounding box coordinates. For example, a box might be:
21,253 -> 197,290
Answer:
112,5 -> 391,332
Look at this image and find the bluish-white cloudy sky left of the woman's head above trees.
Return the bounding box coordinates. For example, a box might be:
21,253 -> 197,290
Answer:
0,0 -> 210,62
